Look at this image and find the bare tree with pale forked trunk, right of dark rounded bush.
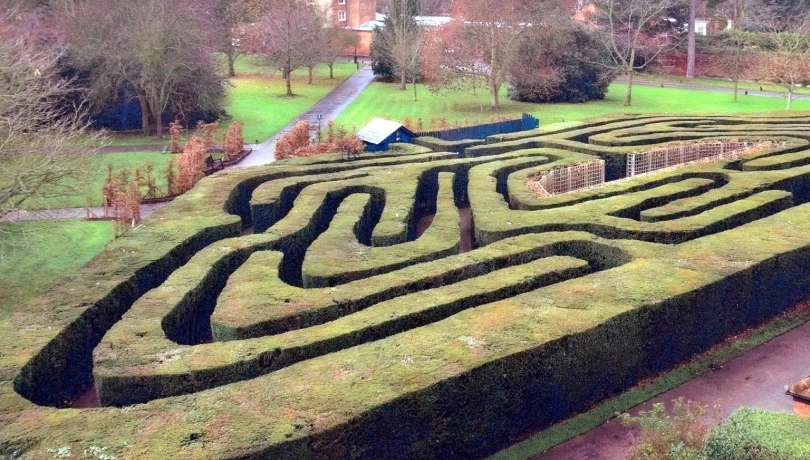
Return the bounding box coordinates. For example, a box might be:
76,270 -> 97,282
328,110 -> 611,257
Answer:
596,0 -> 683,106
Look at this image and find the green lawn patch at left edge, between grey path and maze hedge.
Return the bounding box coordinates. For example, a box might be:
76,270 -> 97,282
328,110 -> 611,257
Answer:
0,219 -> 112,323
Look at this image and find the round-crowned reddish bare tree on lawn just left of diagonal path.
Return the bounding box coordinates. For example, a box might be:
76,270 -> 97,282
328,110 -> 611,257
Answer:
245,0 -> 324,96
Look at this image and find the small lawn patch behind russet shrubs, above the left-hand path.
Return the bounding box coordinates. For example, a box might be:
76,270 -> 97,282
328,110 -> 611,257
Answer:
23,152 -> 172,210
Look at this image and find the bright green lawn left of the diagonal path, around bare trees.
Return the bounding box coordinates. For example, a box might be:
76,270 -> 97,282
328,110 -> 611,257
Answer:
107,56 -> 357,145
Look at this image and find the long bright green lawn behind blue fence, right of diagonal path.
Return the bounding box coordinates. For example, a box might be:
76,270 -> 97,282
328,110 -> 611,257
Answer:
337,83 -> 810,129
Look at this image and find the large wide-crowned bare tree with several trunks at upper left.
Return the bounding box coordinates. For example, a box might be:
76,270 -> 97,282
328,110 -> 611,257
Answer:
55,0 -> 224,135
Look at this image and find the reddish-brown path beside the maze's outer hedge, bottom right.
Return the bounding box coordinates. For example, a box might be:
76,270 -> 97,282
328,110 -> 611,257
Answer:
530,323 -> 810,460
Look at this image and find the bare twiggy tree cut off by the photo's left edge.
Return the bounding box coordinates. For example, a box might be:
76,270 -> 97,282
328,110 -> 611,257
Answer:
0,10 -> 98,221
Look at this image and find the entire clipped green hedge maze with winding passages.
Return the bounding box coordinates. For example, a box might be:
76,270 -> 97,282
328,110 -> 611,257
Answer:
0,112 -> 810,459
